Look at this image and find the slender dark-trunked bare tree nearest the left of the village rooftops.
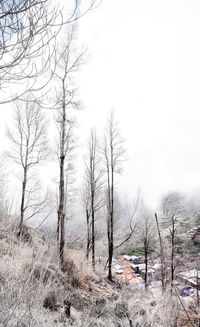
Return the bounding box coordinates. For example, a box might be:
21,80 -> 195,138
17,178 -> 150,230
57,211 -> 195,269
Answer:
103,112 -> 124,281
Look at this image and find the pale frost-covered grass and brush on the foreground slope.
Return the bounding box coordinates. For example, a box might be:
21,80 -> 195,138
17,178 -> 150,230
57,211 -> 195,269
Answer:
0,214 -> 198,327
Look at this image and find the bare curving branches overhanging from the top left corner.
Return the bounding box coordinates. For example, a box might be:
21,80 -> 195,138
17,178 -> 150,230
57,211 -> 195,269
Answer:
0,0 -> 97,103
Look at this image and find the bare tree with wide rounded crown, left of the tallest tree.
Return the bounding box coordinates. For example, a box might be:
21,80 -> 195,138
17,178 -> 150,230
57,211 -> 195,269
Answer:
7,101 -> 48,234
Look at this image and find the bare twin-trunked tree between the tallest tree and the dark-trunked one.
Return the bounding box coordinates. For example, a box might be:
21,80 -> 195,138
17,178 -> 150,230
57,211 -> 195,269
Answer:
84,129 -> 104,269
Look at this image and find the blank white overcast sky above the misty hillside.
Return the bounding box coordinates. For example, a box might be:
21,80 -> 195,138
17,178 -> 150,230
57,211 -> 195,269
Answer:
0,0 -> 200,208
